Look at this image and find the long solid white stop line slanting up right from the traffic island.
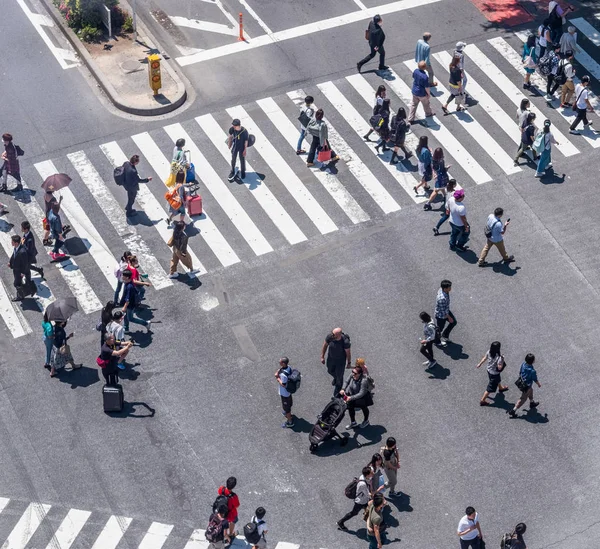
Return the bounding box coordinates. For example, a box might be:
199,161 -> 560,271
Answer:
176,0 -> 440,66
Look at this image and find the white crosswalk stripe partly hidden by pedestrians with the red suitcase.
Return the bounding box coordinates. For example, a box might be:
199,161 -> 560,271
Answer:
132,132 -> 240,267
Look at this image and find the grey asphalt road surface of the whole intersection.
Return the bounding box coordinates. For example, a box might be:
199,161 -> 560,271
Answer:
0,0 -> 600,549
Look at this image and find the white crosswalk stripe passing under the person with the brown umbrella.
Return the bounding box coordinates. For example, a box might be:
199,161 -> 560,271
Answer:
34,160 -> 118,290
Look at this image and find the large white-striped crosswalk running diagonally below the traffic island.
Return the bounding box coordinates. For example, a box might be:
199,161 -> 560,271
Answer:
0,16 -> 600,338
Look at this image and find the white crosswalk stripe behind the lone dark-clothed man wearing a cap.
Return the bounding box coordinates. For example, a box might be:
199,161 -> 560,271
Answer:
196,114 -> 306,244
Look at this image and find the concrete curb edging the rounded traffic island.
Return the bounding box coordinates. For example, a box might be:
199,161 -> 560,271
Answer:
41,0 -> 188,116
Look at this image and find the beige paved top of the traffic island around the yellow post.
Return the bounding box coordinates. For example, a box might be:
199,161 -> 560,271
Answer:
42,0 -> 187,116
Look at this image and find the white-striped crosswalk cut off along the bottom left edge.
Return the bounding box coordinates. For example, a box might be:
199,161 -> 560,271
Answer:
0,497 -> 317,549
